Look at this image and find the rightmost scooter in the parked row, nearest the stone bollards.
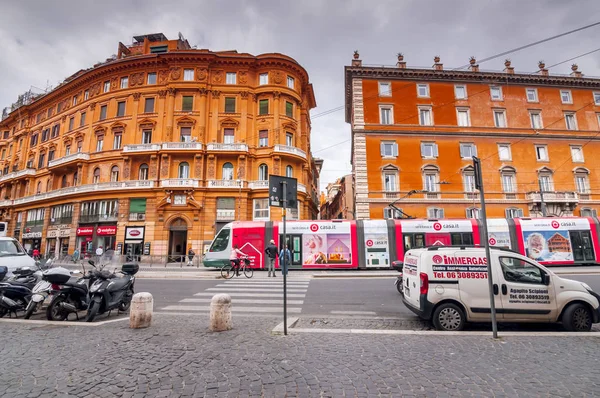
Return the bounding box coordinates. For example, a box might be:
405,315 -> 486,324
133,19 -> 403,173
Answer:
85,263 -> 140,322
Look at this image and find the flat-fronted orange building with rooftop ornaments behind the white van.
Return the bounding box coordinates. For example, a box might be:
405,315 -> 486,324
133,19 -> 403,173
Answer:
345,53 -> 600,219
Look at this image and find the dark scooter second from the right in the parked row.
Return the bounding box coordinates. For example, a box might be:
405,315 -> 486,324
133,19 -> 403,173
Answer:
44,261 -> 98,321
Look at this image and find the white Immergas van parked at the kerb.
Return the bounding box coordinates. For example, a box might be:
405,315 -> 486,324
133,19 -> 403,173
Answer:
403,246 -> 600,331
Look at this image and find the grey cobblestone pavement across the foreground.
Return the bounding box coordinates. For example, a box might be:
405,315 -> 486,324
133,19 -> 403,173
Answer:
0,315 -> 600,398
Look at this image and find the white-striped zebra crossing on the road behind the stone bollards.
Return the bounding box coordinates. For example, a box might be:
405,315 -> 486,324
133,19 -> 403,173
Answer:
160,276 -> 310,315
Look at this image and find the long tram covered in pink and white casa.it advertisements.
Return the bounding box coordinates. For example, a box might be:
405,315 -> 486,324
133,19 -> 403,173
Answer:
203,217 -> 600,269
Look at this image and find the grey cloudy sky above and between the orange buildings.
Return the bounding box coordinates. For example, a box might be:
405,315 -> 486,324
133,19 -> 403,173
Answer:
0,0 -> 600,193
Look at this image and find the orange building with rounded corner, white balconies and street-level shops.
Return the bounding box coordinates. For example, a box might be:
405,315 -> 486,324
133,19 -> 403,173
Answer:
0,33 -> 318,256
